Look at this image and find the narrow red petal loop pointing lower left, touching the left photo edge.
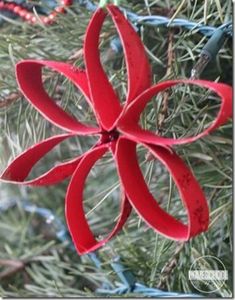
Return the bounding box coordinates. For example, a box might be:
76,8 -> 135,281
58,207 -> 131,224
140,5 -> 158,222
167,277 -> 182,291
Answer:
0,134 -> 82,186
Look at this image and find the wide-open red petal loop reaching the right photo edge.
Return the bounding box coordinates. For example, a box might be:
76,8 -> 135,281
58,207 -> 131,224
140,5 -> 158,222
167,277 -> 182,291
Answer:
117,80 -> 232,146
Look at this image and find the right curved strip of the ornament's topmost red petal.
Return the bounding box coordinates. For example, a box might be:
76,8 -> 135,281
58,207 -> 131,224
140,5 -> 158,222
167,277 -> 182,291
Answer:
107,5 -> 151,104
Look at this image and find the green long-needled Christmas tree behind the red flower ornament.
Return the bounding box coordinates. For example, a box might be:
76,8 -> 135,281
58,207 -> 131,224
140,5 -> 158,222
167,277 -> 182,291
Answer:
0,0 -> 233,297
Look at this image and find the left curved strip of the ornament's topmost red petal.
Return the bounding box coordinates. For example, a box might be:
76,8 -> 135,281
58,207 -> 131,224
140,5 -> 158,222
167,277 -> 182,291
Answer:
84,9 -> 122,131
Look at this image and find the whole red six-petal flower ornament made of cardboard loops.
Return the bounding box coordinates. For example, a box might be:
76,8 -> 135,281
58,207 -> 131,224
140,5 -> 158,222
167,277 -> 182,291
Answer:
1,5 -> 232,254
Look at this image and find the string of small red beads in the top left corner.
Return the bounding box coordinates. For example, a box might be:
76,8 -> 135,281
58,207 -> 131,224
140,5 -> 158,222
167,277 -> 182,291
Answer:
0,0 -> 73,25
